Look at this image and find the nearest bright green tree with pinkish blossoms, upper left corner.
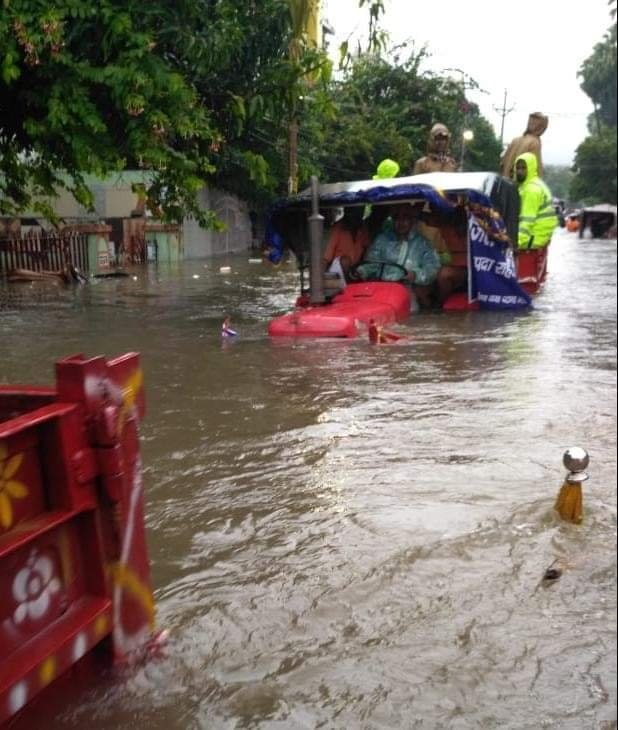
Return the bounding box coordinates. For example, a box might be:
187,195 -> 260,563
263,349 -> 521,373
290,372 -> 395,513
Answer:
0,0 -> 215,223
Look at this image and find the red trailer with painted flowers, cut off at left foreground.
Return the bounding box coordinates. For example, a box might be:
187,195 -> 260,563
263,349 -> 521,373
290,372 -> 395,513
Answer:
0,354 -> 154,725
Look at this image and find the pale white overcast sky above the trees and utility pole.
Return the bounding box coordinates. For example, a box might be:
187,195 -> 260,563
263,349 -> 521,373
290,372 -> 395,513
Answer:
322,0 -> 612,165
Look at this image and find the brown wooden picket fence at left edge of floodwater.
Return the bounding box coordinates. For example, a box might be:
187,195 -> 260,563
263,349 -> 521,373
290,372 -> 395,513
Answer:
0,232 -> 89,275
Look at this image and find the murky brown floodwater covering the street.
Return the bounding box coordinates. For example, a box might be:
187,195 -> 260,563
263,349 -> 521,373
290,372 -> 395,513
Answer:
0,232 -> 617,730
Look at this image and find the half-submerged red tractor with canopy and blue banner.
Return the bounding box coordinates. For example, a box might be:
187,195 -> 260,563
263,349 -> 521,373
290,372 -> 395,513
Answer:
268,172 -> 536,338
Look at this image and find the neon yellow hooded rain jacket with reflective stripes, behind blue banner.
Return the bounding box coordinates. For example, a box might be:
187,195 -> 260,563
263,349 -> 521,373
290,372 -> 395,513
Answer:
515,152 -> 558,249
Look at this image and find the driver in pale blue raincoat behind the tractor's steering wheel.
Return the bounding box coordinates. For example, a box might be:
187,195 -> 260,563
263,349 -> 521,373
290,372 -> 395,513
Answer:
356,203 -> 440,306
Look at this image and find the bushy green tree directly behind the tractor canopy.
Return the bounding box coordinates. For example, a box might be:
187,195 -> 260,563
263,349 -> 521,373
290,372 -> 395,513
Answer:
302,49 -> 500,181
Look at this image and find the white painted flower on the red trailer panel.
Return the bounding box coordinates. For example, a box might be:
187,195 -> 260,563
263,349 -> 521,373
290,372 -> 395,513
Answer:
13,550 -> 61,625
